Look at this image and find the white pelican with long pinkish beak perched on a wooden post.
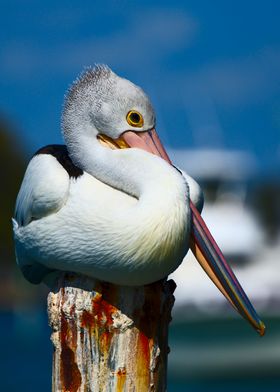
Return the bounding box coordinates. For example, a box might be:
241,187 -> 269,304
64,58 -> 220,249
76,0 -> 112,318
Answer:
13,65 -> 265,335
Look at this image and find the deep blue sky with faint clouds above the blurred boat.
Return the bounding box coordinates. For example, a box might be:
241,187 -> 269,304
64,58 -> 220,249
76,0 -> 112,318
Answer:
0,0 -> 280,173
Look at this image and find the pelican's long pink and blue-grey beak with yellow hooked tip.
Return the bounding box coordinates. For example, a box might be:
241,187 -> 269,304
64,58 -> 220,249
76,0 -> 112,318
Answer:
100,129 -> 265,336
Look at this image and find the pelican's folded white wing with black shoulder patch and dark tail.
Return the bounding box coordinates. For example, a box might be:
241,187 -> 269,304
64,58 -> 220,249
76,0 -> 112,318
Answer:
13,145 -> 83,283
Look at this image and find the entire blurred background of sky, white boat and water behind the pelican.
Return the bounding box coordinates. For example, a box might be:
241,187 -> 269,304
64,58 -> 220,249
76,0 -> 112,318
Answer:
0,0 -> 280,392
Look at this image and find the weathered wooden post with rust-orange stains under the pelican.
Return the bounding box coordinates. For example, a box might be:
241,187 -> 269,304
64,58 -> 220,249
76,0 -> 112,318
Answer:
48,273 -> 176,392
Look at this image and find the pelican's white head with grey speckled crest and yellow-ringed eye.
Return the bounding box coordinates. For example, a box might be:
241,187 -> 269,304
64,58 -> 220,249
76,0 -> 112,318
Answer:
62,65 -> 155,145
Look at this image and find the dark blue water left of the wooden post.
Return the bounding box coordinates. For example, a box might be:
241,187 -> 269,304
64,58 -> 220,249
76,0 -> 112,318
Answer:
0,311 -> 52,392
